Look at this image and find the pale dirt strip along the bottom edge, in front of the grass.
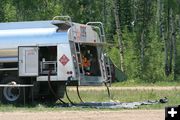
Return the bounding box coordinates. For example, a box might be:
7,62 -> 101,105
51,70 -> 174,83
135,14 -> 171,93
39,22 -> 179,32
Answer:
0,110 -> 165,120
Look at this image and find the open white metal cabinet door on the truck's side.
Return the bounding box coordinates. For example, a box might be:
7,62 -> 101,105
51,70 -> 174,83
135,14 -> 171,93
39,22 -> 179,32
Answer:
18,46 -> 39,76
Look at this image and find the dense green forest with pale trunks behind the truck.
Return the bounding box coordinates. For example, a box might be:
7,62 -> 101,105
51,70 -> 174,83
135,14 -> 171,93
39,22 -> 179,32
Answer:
0,0 -> 180,82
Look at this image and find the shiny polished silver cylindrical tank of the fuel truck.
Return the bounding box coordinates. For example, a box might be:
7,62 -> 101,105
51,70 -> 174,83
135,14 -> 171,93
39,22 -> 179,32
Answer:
0,21 -> 68,62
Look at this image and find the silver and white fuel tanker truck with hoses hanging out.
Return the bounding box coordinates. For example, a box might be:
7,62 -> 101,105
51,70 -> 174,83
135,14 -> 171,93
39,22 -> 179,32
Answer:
0,16 -> 111,103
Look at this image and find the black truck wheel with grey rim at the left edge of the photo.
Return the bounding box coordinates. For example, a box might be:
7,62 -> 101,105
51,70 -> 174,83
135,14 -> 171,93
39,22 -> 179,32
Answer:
0,77 -> 24,104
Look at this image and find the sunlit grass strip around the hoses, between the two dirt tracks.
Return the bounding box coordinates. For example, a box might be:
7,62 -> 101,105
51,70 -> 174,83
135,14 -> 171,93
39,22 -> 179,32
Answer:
0,89 -> 180,112
